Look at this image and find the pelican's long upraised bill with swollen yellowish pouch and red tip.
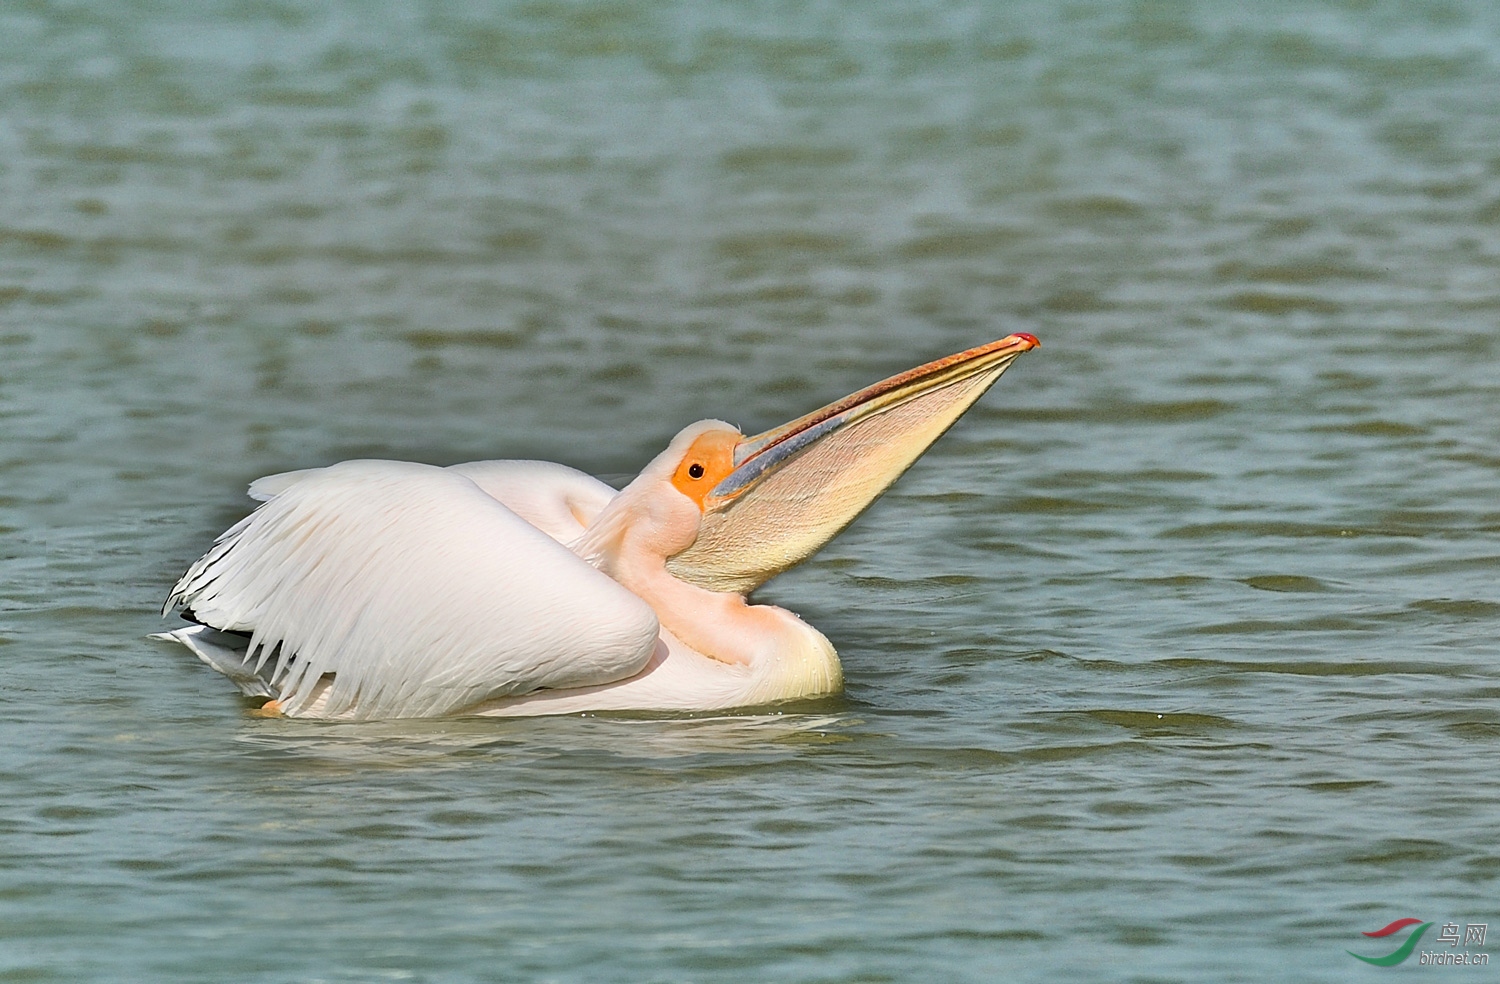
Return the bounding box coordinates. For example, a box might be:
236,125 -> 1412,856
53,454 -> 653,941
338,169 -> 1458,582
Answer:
668,333 -> 1040,594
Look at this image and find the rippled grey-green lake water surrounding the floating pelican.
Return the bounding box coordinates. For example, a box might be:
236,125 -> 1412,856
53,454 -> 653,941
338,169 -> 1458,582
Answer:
0,0 -> 1500,984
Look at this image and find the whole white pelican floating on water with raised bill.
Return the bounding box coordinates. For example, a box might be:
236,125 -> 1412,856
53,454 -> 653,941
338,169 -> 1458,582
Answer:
156,333 -> 1038,719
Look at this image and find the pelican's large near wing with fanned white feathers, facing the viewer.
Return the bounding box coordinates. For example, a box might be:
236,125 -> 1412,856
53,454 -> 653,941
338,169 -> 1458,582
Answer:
165,461 -> 659,717
